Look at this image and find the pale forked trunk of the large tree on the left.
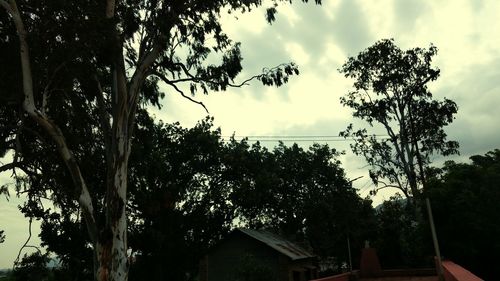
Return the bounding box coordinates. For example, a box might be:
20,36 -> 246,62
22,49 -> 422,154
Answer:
0,0 -> 164,281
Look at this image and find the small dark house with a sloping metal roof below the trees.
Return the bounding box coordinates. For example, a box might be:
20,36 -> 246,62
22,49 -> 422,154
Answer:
200,228 -> 317,281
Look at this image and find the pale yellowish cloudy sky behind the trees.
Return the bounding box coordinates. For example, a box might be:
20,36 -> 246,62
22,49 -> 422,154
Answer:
0,0 -> 500,268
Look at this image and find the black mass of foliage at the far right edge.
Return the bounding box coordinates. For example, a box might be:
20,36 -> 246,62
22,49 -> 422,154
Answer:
428,149 -> 500,280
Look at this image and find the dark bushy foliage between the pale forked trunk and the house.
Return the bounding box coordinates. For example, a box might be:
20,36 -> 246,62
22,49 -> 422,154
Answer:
126,116 -> 234,280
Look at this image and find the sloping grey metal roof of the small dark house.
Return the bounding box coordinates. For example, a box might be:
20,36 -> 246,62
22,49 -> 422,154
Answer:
236,228 -> 315,260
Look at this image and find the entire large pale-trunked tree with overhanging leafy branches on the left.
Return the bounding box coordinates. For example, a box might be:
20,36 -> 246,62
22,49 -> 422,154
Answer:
0,0 -> 320,280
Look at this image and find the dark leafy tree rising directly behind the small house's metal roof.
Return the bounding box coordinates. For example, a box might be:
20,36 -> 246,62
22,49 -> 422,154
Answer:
229,143 -> 373,261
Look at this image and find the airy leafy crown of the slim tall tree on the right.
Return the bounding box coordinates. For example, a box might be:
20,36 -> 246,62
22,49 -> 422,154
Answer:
339,39 -> 458,202
